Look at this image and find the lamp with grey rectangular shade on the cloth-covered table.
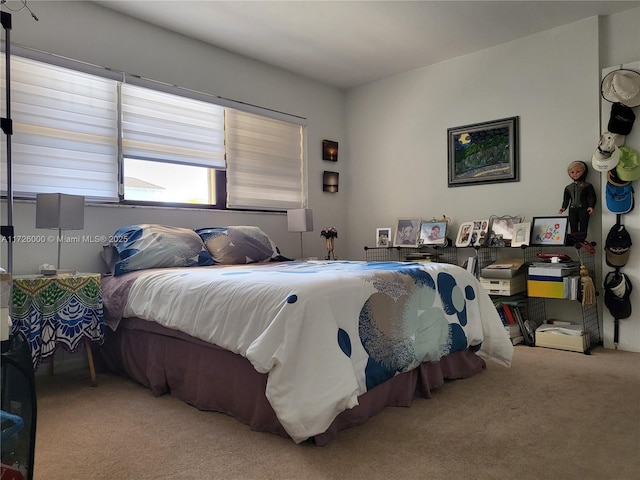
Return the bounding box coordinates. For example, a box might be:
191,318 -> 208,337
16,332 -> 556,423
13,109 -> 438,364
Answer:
36,193 -> 84,272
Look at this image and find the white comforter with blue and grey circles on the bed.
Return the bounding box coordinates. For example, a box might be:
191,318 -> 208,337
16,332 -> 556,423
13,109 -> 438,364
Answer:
123,261 -> 513,442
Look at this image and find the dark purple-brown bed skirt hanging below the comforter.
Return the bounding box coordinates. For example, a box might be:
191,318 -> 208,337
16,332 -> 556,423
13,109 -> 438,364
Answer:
95,318 -> 485,446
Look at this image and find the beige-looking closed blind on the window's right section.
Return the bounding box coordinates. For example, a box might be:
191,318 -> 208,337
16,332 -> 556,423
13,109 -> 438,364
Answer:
226,109 -> 304,210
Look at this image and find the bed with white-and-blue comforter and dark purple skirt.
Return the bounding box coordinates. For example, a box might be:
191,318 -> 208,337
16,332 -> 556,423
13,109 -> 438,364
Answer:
100,226 -> 513,445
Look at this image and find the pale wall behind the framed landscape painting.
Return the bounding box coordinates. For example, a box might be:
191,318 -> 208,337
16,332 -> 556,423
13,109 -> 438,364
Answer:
347,17 -> 600,257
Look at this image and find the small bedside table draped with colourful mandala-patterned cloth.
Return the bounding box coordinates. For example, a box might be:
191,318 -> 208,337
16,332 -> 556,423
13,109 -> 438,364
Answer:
11,273 -> 104,386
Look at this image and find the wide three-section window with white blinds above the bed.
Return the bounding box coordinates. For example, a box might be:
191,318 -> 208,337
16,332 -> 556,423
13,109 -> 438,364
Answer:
2,49 -> 305,210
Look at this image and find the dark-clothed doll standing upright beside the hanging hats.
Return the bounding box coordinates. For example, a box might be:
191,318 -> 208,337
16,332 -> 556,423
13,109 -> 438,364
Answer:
558,160 -> 596,241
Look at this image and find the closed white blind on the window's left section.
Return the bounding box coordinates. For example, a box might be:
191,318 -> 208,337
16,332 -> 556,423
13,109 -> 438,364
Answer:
2,54 -> 118,200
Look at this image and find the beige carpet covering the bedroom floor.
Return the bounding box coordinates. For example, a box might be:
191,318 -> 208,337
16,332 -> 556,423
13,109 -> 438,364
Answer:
35,346 -> 640,480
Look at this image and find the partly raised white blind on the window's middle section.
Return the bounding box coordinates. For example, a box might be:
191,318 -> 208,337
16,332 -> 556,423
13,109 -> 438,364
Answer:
122,83 -> 225,168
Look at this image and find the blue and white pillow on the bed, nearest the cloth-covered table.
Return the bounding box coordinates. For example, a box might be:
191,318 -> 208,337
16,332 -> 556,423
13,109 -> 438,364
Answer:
113,224 -> 214,275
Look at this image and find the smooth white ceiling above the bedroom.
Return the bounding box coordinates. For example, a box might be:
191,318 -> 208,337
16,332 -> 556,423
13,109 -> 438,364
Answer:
93,0 -> 640,88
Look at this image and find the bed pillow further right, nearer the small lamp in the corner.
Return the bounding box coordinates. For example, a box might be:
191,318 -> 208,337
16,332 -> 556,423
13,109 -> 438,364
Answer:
196,226 -> 291,265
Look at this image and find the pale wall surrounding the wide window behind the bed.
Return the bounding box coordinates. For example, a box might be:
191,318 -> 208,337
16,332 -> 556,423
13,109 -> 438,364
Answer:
0,1 -> 346,274
